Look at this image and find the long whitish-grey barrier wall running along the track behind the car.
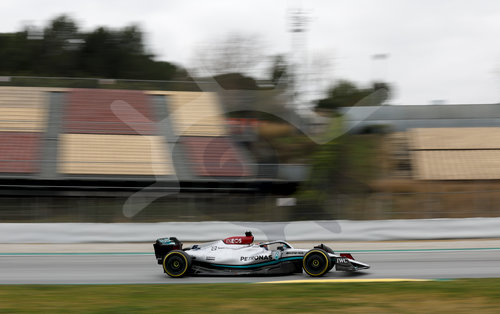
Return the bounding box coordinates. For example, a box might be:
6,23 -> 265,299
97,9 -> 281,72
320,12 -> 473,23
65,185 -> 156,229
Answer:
0,218 -> 500,243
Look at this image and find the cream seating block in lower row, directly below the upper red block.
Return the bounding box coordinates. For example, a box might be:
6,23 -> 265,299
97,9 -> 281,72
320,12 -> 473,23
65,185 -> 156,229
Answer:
58,134 -> 174,175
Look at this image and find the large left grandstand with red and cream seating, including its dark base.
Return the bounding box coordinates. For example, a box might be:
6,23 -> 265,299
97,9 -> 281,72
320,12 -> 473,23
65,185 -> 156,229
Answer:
0,78 -> 305,221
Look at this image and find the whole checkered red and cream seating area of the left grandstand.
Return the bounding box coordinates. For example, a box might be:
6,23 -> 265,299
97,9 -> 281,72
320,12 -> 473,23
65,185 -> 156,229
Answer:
0,87 -> 250,179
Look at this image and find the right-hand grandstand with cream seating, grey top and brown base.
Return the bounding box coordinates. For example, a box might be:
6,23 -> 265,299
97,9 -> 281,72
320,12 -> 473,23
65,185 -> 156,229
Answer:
342,104 -> 500,218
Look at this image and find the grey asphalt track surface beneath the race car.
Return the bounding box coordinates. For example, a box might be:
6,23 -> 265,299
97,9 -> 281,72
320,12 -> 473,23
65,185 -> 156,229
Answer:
0,248 -> 500,284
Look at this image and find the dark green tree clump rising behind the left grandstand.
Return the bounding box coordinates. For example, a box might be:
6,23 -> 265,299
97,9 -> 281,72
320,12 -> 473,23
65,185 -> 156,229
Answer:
0,15 -> 184,80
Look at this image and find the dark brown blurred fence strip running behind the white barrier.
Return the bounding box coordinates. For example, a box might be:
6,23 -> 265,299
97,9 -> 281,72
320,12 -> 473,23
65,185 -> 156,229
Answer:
0,189 -> 500,222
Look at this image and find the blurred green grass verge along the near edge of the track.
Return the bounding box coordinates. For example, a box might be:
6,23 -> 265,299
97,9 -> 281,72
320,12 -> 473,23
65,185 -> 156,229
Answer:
0,279 -> 500,313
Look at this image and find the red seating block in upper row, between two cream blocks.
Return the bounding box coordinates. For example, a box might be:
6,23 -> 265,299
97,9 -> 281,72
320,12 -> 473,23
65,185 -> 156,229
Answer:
63,89 -> 155,135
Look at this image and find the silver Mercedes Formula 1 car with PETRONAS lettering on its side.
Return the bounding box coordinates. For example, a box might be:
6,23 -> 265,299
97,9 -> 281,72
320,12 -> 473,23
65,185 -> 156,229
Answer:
153,232 -> 370,278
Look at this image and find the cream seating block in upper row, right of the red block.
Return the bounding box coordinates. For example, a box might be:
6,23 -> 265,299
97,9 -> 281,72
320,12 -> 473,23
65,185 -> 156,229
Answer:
148,91 -> 227,136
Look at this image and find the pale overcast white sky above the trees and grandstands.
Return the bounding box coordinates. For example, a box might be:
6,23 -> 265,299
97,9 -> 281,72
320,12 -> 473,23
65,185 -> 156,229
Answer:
0,0 -> 500,105
